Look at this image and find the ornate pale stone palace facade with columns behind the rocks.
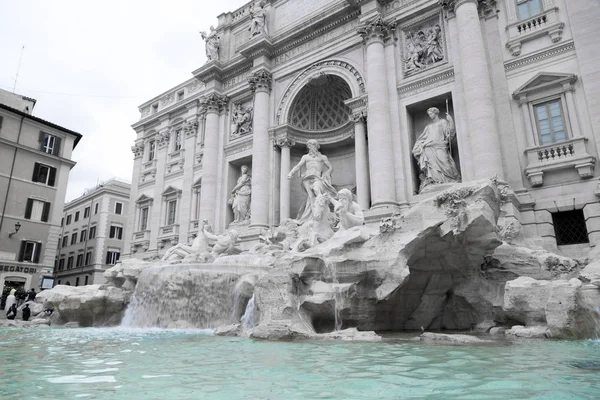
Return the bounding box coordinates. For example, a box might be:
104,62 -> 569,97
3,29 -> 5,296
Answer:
124,0 -> 600,257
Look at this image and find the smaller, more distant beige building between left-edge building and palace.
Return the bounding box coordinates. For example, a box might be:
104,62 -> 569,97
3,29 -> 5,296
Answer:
54,179 -> 131,286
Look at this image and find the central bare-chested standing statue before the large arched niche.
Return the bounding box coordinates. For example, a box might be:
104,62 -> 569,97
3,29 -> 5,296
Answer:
287,139 -> 337,224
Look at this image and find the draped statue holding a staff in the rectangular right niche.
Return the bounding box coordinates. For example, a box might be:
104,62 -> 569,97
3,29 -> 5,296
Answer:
412,107 -> 460,192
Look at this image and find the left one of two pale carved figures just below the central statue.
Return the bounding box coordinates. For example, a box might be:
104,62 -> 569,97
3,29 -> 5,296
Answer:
292,193 -> 333,251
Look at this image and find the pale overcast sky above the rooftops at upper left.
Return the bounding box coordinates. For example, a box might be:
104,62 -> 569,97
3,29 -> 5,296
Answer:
0,0 -> 247,201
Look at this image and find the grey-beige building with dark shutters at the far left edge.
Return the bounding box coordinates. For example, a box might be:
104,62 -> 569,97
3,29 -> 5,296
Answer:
0,90 -> 82,290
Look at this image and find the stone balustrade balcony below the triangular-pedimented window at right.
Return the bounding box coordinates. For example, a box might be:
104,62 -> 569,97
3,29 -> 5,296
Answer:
525,137 -> 596,187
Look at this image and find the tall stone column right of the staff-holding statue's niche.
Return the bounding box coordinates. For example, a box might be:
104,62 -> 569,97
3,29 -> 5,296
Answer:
440,0 -> 504,178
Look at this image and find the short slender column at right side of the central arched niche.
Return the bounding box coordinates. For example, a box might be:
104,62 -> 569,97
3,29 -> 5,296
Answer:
352,111 -> 371,210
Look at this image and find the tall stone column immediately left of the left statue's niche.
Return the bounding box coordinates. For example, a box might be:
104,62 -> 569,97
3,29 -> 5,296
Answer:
199,93 -> 228,228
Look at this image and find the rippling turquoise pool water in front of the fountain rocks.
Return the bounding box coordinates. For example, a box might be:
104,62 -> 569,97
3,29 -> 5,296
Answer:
0,328 -> 600,400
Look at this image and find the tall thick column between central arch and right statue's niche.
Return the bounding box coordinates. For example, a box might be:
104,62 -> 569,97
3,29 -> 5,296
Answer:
358,16 -> 397,207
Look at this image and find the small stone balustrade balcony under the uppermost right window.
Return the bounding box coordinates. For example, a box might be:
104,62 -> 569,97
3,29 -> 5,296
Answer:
506,7 -> 565,56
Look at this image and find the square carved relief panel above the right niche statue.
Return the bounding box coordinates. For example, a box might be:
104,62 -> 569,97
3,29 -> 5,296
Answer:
404,24 -> 444,71
